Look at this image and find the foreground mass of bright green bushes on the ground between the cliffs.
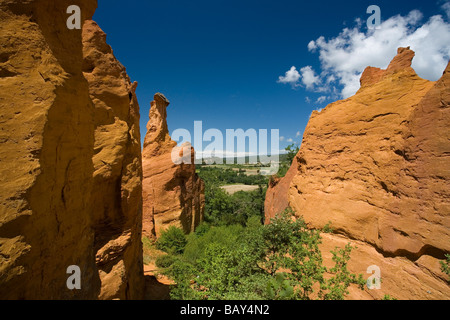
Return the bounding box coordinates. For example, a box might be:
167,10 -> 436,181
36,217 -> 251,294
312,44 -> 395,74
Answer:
158,211 -> 364,299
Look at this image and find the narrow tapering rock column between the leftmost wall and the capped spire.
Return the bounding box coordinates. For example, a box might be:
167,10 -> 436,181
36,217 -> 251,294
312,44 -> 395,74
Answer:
83,20 -> 144,299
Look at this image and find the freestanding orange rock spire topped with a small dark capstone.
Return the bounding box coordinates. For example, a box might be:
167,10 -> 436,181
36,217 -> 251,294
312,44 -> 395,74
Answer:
142,93 -> 205,237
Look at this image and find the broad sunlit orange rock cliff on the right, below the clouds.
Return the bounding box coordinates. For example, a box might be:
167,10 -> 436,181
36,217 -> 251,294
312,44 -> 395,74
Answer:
266,48 -> 450,299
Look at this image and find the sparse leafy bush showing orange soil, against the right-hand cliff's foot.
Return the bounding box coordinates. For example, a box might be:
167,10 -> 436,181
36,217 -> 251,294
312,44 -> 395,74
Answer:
263,208 -> 364,300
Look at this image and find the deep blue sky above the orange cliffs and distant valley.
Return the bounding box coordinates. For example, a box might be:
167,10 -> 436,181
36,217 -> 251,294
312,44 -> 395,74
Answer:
94,0 -> 450,155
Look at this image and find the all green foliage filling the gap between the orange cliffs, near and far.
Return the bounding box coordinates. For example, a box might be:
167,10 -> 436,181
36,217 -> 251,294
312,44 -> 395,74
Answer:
156,161 -> 365,300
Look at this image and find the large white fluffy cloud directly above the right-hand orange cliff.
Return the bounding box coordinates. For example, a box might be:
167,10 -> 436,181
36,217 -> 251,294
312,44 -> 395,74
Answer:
280,7 -> 450,97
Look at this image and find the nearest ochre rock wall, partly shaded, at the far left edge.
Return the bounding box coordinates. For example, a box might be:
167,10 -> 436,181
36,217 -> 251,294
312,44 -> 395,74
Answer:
0,0 -> 100,299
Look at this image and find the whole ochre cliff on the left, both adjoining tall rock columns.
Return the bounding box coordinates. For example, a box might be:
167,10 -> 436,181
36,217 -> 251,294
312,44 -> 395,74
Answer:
0,0 -> 143,299
